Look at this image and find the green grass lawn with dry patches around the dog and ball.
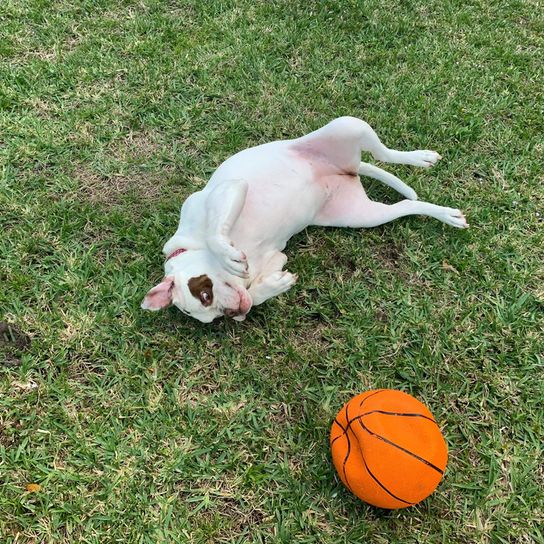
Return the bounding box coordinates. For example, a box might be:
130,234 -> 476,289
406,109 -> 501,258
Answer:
0,0 -> 544,544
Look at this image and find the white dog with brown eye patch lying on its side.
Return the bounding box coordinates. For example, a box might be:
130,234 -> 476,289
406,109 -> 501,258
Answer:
142,117 -> 468,323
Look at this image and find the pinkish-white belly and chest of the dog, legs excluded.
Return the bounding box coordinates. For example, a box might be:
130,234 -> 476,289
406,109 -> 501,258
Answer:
209,141 -> 330,258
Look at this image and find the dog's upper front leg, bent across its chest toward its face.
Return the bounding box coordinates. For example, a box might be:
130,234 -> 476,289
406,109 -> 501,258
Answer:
206,180 -> 248,278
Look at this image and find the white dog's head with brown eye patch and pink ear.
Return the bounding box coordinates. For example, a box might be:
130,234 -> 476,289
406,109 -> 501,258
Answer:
142,250 -> 252,323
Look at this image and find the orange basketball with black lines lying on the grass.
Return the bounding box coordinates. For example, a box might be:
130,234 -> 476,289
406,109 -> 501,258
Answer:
331,389 -> 448,509
